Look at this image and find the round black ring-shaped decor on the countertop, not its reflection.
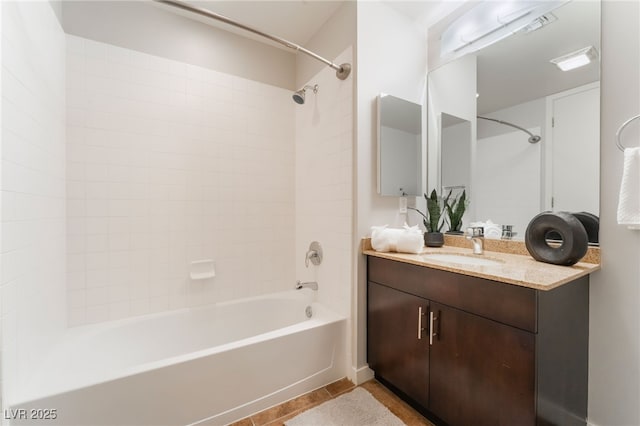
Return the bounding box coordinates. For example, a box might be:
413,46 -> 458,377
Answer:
524,212 -> 588,266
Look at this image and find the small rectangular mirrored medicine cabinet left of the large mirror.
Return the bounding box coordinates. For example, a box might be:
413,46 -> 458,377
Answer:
378,94 -> 424,197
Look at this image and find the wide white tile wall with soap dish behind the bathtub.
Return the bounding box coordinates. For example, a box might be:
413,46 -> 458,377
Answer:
66,36 -> 295,325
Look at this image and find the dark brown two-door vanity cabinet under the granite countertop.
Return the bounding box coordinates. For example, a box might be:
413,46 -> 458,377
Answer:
367,256 -> 589,426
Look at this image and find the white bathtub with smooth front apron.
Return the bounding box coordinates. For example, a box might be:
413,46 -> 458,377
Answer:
10,289 -> 346,426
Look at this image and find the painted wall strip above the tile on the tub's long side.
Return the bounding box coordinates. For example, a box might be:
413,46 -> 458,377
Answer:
62,0 -> 296,90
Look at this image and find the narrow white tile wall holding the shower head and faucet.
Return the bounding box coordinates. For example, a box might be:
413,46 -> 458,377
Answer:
295,48 -> 354,316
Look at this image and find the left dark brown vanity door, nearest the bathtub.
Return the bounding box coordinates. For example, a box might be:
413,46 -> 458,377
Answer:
367,282 -> 429,407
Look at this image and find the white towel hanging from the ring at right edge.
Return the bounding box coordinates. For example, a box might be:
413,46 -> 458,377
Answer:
618,148 -> 640,229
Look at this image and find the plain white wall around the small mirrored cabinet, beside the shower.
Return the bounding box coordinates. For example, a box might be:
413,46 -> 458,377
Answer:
353,1 -> 426,377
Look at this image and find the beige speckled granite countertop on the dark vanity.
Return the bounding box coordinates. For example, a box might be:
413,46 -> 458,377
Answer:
362,239 -> 600,290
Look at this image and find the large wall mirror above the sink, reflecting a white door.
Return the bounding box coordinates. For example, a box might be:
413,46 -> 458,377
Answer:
427,1 -> 600,239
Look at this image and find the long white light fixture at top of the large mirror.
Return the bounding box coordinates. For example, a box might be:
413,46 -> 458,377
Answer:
440,0 -> 569,57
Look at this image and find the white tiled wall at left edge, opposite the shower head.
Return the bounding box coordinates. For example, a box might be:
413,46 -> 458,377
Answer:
0,2 -> 65,406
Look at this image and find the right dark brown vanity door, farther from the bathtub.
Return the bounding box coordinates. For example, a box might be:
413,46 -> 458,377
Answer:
428,302 -> 535,426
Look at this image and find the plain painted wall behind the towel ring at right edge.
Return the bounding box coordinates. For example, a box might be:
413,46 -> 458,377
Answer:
589,1 -> 640,426
